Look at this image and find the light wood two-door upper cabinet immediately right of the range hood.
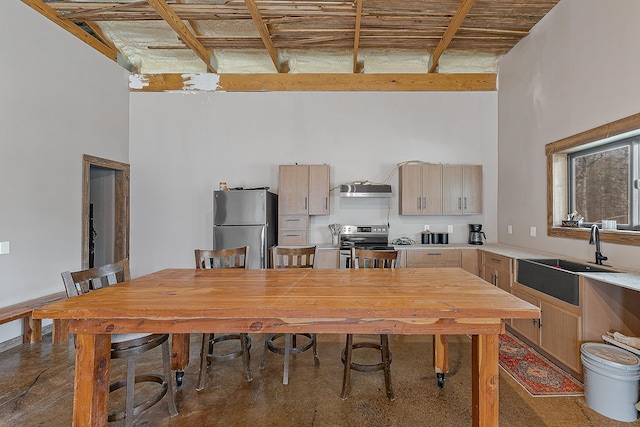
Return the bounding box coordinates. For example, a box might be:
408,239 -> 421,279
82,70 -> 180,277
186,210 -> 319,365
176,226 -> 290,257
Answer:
399,164 -> 442,215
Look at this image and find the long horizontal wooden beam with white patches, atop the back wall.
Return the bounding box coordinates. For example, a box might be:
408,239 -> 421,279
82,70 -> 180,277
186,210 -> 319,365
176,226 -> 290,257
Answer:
129,73 -> 497,92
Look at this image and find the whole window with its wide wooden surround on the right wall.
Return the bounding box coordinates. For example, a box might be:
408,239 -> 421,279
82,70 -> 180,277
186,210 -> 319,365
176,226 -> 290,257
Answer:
545,113 -> 640,246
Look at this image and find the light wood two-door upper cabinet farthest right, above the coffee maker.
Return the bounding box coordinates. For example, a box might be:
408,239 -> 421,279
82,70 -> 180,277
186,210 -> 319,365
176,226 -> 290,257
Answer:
442,165 -> 482,215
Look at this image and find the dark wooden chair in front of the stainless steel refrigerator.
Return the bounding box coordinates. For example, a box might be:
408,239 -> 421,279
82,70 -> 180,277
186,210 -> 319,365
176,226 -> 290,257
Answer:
195,246 -> 252,391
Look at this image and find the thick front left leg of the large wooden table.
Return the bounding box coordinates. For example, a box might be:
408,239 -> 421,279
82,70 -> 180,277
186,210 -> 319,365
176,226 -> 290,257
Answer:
73,334 -> 111,426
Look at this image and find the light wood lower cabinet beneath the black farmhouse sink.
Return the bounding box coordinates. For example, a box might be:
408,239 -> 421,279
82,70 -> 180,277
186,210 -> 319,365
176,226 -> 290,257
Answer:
511,283 -> 582,375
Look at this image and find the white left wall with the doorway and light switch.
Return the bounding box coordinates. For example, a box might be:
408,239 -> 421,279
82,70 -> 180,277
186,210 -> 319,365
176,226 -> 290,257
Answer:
0,0 -> 129,342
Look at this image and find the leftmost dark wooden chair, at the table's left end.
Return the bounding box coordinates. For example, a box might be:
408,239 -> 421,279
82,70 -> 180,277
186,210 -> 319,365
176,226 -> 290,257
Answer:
62,259 -> 178,426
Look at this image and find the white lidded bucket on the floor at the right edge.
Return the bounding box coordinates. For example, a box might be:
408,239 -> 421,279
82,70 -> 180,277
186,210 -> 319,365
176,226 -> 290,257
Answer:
580,343 -> 640,422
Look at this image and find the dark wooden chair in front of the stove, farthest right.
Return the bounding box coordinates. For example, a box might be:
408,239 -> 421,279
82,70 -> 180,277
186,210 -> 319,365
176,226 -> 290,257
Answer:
342,248 -> 398,400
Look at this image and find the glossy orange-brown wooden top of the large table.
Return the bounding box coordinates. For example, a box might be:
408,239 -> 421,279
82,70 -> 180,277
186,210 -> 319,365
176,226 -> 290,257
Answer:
34,268 -> 540,330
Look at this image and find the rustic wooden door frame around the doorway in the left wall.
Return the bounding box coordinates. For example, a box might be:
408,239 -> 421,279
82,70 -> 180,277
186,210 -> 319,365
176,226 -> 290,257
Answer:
82,154 -> 130,269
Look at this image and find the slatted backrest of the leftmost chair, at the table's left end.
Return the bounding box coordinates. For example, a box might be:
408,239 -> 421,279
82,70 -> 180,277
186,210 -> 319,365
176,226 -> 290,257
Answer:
62,259 -> 131,298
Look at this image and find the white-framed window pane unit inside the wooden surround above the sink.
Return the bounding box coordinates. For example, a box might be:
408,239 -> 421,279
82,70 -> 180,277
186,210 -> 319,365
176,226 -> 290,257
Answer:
567,137 -> 640,230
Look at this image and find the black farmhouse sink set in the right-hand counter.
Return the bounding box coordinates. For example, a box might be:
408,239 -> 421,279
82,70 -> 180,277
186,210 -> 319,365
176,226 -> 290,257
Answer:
516,258 -> 617,306
